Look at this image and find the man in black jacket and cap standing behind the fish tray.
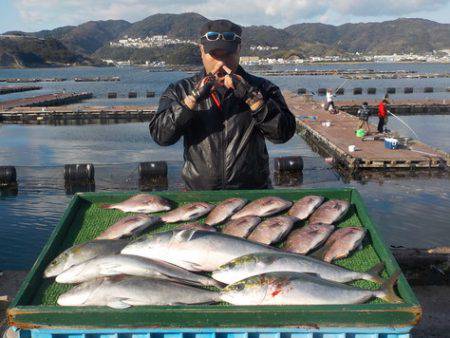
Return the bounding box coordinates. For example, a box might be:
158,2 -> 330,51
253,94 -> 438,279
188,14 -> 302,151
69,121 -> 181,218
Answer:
150,20 -> 295,190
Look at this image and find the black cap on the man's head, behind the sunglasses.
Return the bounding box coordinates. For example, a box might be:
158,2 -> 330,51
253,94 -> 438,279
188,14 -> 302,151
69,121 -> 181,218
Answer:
200,20 -> 242,53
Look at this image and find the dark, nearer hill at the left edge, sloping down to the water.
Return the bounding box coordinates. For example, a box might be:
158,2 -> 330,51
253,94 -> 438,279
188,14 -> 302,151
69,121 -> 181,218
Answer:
0,35 -> 95,68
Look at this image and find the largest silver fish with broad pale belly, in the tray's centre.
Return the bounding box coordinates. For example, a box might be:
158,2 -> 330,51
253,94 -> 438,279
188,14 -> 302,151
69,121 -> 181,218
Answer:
122,229 -> 280,271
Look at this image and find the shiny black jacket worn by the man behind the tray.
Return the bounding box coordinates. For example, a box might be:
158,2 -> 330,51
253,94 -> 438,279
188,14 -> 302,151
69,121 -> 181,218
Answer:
149,67 -> 296,190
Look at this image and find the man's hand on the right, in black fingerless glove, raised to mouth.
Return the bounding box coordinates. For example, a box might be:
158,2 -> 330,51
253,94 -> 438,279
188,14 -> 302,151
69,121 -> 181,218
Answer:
223,66 -> 264,111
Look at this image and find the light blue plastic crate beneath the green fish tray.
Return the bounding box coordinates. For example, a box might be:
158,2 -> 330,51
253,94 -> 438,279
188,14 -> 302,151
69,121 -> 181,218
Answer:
11,326 -> 412,338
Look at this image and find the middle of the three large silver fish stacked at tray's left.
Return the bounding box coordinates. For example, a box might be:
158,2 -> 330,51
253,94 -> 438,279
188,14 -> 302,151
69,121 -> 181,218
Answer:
55,255 -> 219,286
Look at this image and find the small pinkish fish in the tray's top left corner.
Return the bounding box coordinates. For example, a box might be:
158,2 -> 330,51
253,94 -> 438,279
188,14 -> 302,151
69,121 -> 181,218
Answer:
101,194 -> 172,213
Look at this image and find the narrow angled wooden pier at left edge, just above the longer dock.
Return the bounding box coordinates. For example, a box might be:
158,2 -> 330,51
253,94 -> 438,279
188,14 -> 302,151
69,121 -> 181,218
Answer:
0,92 -> 92,111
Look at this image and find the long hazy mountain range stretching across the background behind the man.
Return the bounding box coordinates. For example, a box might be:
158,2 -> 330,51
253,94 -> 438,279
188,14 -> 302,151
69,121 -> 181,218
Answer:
0,13 -> 450,67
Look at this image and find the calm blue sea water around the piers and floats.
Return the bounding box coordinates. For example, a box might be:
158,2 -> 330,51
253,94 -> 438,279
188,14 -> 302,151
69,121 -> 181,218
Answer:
0,64 -> 450,270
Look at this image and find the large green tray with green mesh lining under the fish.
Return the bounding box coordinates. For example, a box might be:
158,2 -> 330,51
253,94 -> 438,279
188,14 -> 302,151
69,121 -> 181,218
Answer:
7,189 -> 422,338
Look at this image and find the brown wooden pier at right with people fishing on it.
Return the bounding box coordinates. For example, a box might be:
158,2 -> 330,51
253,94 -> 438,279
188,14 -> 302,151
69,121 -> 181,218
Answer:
284,92 -> 450,172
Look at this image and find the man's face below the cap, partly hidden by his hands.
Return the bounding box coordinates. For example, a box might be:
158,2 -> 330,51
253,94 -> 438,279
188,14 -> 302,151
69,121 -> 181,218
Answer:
200,45 -> 241,78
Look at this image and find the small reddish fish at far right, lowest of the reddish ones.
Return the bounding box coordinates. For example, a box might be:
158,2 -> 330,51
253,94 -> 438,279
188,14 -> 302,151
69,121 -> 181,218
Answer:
323,227 -> 366,262
